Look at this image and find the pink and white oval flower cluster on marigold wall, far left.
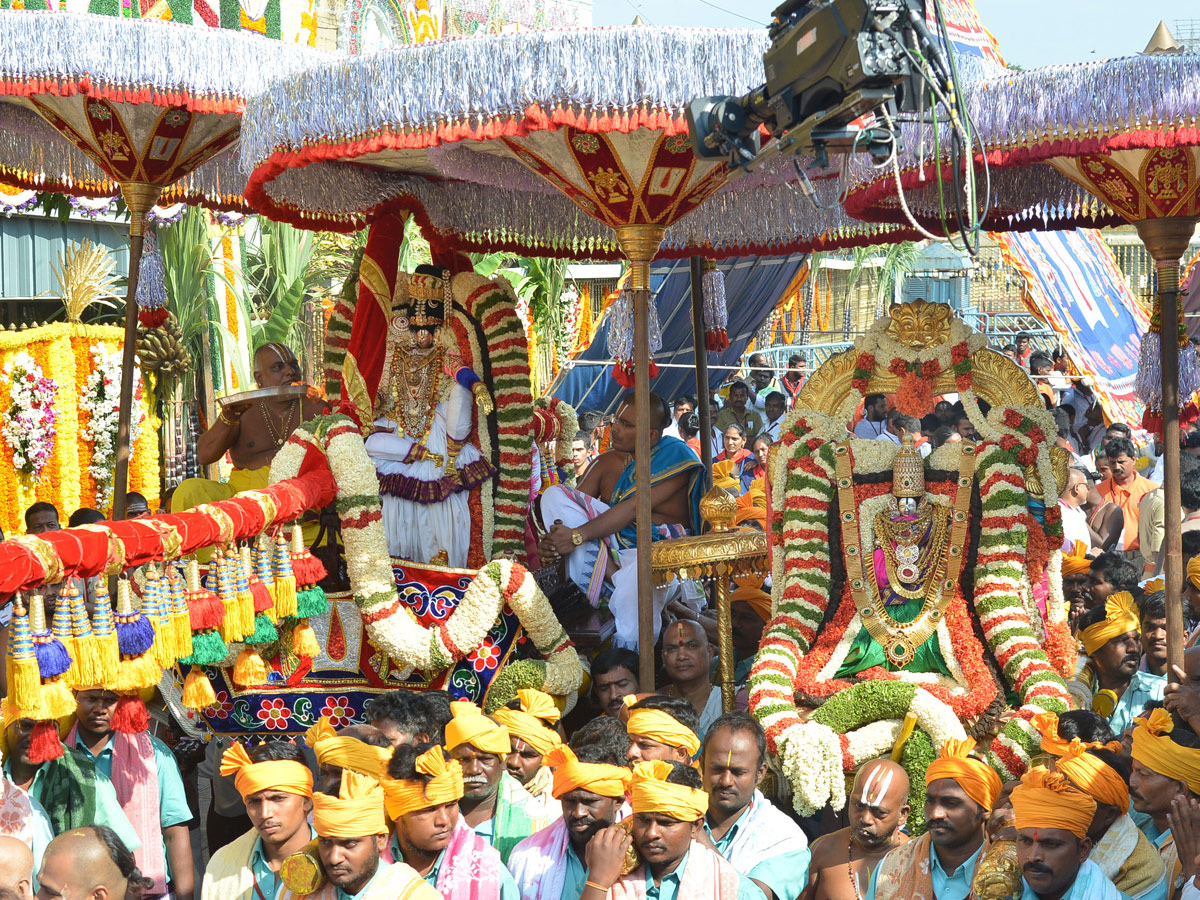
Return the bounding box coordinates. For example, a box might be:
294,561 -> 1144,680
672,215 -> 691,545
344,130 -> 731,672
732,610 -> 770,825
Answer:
0,352 -> 59,494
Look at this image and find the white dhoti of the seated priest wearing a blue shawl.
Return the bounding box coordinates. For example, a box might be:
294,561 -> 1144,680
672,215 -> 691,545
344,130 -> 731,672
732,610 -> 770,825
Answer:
541,485 -> 701,650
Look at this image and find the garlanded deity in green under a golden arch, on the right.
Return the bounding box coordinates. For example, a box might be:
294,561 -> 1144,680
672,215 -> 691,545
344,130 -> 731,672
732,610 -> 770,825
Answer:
750,300 -> 1075,827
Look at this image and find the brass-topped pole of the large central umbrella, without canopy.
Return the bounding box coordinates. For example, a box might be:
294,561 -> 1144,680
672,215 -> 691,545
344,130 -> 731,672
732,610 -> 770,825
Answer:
617,224 -> 666,690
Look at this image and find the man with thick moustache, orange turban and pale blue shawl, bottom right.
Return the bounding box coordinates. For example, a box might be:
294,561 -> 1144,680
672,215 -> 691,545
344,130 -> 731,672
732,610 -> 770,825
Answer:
1013,766 -> 1126,900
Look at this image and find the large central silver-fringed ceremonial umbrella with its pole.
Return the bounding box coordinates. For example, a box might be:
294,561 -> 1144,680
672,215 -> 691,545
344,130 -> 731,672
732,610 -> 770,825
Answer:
241,26 -> 910,683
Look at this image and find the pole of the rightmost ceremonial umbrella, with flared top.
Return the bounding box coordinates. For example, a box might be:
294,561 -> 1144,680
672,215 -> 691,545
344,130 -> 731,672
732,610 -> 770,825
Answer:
1138,218 -> 1196,680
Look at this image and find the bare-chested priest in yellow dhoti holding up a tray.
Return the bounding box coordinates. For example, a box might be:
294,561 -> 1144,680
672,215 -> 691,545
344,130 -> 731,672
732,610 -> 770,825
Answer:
170,342 -> 325,512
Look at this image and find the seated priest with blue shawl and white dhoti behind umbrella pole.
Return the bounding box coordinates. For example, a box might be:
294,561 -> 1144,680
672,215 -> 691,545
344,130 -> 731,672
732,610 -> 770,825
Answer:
539,391 -> 703,647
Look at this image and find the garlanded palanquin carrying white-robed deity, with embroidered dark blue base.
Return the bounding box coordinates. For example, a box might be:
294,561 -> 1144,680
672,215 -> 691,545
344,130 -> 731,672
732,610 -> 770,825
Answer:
177,216 -> 582,733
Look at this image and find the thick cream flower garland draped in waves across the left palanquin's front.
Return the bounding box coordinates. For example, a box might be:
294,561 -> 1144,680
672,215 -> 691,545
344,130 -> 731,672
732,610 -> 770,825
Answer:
271,415 -> 583,695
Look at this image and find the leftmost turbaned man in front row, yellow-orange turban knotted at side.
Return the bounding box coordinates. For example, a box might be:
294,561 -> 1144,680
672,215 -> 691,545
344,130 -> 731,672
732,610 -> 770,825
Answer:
200,740 -> 316,900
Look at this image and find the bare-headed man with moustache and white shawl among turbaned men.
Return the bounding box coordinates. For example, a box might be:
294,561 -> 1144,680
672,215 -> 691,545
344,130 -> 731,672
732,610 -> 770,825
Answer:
701,713 -> 810,900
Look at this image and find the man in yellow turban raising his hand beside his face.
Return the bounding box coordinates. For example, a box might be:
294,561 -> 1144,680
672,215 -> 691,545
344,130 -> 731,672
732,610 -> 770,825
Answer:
582,760 -> 762,900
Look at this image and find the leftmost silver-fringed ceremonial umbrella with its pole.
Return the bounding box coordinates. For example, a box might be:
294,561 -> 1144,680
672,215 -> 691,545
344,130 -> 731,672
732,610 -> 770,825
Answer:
0,10 -> 325,518
